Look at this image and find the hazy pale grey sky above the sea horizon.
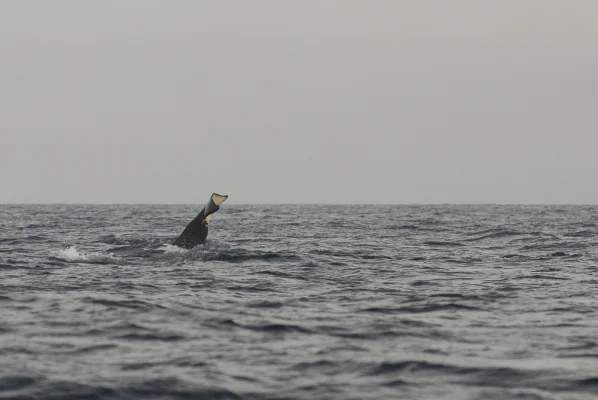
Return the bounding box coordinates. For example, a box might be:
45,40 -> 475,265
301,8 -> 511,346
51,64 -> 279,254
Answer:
0,0 -> 598,203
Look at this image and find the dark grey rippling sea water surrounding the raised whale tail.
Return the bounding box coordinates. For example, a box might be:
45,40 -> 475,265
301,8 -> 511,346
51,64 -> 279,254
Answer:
0,204 -> 598,399
